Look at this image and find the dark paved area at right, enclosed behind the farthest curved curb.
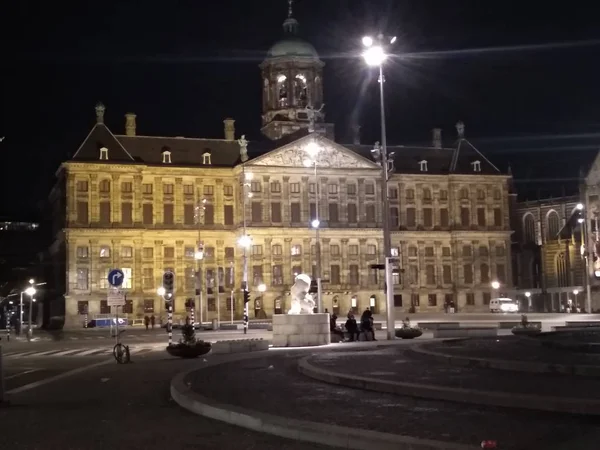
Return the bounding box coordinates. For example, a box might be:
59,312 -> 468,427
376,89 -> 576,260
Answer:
424,336 -> 600,366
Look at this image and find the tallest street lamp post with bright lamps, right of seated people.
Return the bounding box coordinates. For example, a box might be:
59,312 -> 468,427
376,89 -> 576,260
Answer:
362,34 -> 396,340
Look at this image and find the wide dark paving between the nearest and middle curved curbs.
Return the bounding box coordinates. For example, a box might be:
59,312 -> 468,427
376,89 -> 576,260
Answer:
187,352 -> 593,450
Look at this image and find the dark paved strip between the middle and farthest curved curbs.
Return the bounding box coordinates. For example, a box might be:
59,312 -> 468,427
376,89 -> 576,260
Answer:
311,346 -> 600,398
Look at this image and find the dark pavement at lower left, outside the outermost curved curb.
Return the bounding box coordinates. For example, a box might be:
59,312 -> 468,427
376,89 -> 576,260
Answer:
0,353 -> 330,450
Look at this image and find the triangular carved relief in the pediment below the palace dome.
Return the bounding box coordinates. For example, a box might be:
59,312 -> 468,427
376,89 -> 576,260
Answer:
252,147 -> 375,169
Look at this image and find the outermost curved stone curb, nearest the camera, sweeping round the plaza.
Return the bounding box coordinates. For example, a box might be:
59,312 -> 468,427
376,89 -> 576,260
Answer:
170,355 -> 478,450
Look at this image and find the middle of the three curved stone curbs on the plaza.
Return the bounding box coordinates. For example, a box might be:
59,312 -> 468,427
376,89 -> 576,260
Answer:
298,356 -> 600,415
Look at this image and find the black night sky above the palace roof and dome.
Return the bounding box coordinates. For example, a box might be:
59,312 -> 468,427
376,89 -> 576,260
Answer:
0,0 -> 600,217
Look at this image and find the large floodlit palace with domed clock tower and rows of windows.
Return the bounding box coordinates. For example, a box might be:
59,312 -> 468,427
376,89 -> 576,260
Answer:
51,7 -> 512,326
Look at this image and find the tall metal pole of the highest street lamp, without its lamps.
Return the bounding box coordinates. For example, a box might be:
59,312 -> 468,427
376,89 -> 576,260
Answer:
379,63 -> 396,340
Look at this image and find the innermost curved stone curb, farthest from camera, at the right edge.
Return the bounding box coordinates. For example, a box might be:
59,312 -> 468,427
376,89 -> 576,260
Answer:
407,344 -> 600,377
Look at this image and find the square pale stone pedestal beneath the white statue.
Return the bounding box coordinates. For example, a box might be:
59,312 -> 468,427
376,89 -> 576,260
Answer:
273,313 -> 331,347
